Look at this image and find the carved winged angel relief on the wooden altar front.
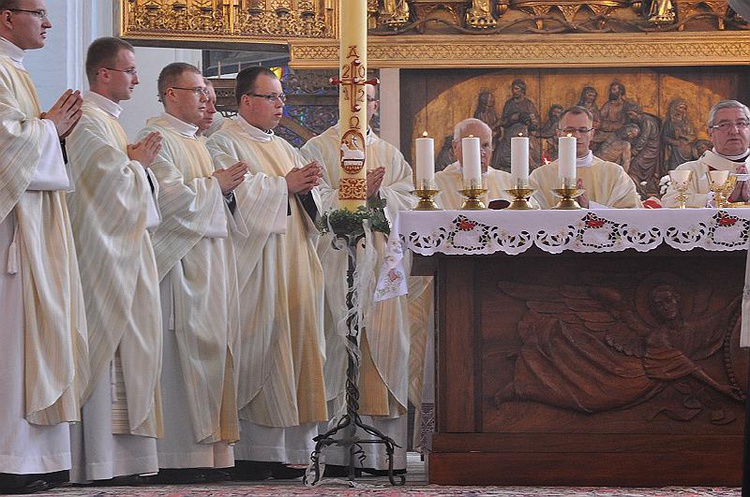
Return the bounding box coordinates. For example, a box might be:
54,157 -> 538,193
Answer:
494,274 -> 744,422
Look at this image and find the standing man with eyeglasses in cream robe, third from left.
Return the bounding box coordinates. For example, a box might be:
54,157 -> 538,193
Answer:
139,62 -> 247,482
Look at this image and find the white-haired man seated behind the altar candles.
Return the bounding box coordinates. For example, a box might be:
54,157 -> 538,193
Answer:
435,117 -> 524,209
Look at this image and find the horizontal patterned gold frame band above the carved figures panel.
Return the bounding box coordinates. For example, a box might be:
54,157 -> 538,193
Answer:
289,31 -> 750,69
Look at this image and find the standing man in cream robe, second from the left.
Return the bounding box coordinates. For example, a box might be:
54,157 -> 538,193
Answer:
67,38 -> 162,483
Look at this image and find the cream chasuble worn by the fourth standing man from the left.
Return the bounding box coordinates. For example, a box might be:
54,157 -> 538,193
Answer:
208,117 -> 327,428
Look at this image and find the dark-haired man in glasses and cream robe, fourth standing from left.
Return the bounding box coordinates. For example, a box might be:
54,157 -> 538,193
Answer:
208,66 -> 328,478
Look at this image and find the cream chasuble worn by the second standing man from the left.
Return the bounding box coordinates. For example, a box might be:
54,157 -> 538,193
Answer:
67,93 -> 162,437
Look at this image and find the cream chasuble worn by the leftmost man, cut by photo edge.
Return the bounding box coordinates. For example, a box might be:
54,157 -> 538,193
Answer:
0,40 -> 89,425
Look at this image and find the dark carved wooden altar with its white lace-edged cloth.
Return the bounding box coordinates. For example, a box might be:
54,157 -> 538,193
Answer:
388,209 -> 750,487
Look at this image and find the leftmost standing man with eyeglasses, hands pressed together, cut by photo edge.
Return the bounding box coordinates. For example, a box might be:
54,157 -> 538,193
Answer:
0,0 -> 88,493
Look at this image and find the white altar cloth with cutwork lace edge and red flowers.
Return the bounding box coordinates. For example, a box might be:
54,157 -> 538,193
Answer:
375,209 -> 750,300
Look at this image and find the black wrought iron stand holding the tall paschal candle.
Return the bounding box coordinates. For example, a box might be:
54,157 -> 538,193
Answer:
304,233 -> 406,485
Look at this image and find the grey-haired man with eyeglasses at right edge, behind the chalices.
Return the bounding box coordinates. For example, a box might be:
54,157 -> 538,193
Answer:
661,100 -> 750,207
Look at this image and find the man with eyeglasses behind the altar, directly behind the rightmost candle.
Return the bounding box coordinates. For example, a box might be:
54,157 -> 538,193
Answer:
529,106 -> 641,209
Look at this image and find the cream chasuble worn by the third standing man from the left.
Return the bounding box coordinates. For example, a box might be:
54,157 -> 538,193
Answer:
138,114 -> 239,443
